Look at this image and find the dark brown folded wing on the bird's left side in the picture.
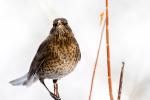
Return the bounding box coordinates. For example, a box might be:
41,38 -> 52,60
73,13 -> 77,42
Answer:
28,39 -> 48,79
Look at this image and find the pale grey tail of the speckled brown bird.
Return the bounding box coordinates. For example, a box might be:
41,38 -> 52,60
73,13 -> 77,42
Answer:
9,73 -> 37,86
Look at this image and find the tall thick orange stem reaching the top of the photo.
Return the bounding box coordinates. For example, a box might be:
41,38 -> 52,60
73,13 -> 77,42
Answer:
106,0 -> 113,100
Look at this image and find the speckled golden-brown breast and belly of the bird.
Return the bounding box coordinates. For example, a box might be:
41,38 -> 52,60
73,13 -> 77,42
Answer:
38,37 -> 81,79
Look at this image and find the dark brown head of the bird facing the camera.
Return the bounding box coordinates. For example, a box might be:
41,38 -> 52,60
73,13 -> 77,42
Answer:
50,18 -> 72,34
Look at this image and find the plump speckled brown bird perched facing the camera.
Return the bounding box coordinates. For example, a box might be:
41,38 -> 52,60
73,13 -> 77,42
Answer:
10,18 -> 81,100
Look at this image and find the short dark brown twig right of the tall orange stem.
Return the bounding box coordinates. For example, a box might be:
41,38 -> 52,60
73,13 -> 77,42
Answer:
117,62 -> 125,100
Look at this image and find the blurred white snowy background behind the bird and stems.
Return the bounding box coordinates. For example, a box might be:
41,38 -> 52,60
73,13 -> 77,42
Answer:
0,0 -> 150,100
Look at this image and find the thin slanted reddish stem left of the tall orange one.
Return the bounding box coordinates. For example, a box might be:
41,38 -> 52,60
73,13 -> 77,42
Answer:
89,17 -> 106,100
